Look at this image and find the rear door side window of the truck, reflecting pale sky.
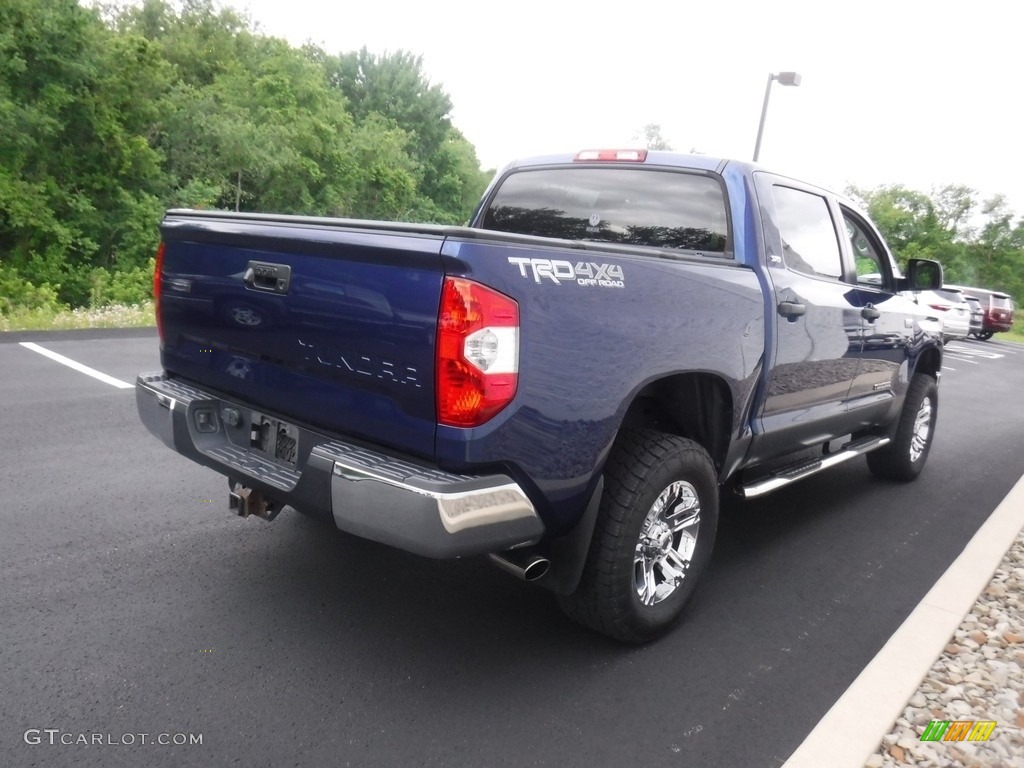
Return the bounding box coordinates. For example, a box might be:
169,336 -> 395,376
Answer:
774,186 -> 843,280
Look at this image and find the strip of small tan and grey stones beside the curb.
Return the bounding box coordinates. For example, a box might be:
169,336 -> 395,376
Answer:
865,531 -> 1024,768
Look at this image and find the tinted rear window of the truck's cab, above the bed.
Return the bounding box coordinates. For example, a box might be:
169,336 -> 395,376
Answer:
482,166 -> 731,257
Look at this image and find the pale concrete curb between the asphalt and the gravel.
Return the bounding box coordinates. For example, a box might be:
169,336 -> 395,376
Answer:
782,477 -> 1024,768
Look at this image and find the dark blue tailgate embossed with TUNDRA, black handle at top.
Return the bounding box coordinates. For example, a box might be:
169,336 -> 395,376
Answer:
160,211 -> 443,458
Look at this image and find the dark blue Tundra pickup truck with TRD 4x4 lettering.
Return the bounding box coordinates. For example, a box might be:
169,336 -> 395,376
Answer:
136,151 -> 942,642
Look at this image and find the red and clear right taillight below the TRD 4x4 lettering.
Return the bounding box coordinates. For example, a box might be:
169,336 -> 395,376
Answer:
436,278 -> 519,427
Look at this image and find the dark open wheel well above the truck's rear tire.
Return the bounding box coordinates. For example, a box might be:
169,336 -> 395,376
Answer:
623,374 -> 732,471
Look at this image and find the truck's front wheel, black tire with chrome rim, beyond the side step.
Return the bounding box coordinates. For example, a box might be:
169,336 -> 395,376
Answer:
867,374 -> 939,482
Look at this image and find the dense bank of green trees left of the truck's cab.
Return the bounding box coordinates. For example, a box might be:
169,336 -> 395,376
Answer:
0,0 -> 487,312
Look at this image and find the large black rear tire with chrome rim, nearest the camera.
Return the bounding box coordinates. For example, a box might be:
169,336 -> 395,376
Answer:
559,430 -> 718,643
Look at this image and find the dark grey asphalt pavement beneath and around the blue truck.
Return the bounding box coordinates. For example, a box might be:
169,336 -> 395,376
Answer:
0,331 -> 1024,768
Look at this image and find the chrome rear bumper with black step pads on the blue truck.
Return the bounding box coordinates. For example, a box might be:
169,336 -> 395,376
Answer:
142,374 -> 544,558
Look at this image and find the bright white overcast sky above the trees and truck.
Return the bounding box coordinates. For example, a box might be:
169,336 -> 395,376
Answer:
235,0 -> 1024,215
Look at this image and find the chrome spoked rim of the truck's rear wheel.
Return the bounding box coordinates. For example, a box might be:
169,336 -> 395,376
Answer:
633,480 -> 700,605
